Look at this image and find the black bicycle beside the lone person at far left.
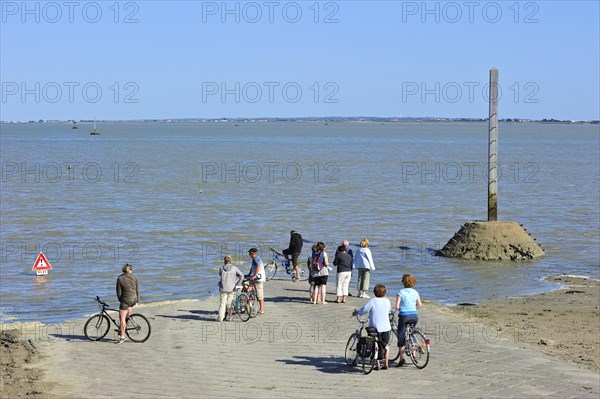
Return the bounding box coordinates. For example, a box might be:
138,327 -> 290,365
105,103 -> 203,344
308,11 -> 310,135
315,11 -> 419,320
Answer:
83,296 -> 152,342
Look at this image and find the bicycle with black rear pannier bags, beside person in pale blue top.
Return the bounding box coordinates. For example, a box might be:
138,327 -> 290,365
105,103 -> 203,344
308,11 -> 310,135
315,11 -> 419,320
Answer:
344,315 -> 385,374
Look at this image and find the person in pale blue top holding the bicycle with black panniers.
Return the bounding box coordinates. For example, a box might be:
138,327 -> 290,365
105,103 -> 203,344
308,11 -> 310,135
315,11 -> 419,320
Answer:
352,284 -> 392,370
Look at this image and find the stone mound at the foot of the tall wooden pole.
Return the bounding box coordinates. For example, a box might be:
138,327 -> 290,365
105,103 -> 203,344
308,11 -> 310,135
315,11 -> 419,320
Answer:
437,221 -> 544,260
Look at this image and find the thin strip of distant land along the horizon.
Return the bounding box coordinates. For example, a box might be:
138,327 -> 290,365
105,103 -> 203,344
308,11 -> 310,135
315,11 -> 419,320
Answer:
0,117 -> 600,125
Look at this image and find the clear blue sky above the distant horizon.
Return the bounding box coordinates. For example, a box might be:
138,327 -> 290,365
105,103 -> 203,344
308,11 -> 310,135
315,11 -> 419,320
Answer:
0,0 -> 600,120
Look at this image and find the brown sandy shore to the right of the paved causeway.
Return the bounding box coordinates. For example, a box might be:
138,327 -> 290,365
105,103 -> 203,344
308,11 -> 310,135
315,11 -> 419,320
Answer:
449,276 -> 600,371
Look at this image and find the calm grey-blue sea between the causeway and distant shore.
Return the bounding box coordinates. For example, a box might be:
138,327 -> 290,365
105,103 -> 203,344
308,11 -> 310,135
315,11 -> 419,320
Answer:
0,123 -> 600,322
